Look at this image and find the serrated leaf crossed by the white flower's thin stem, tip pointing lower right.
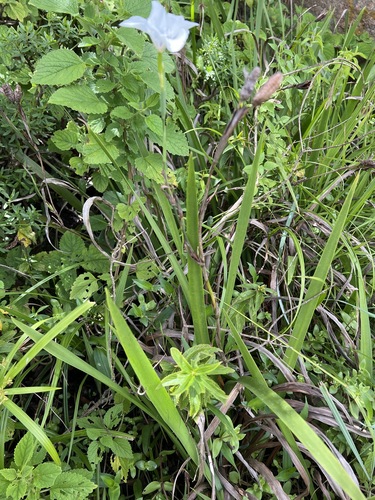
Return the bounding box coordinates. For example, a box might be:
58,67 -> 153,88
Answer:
145,115 -> 189,156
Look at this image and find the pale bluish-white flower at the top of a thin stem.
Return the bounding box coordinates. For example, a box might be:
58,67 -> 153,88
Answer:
120,1 -> 198,52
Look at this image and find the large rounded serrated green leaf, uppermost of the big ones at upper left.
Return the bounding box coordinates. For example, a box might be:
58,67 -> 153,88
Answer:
31,49 -> 86,85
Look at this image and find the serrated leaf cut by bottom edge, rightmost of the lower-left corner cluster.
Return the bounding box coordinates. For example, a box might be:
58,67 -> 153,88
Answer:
49,471 -> 97,500
